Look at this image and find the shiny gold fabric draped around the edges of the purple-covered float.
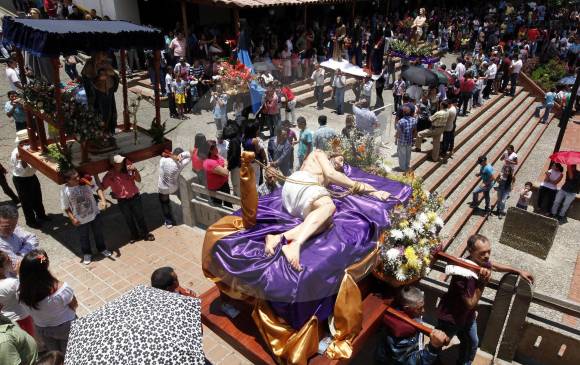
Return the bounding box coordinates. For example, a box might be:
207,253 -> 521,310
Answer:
202,152 -> 378,365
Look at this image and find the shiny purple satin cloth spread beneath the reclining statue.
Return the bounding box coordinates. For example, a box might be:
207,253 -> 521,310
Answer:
212,166 -> 412,329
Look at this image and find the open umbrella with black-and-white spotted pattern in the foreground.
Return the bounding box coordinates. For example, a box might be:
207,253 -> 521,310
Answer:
64,285 -> 205,365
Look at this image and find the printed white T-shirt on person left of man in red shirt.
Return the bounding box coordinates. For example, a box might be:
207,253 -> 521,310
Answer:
60,185 -> 99,224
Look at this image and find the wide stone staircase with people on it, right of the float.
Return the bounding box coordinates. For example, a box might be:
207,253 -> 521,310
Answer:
411,87 -> 555,256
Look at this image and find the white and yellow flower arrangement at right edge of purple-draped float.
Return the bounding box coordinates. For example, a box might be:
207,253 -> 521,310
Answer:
375,176 -> 444,284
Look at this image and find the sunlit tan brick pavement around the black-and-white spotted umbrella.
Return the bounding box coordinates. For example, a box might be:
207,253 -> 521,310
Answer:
51,225 -> 250,365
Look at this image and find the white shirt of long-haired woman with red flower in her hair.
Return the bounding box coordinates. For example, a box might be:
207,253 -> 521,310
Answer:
27,283 -> 76,327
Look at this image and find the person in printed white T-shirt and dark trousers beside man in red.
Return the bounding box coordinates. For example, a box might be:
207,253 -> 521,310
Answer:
60,170 -> 111,265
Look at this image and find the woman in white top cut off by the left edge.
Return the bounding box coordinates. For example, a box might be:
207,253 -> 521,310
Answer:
0,251 -> 34,337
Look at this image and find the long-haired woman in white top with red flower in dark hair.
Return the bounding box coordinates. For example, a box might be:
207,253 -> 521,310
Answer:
18,249 -> 78,353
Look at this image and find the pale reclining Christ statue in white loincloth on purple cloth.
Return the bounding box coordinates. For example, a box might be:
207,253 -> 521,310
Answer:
265,150 -> 391,270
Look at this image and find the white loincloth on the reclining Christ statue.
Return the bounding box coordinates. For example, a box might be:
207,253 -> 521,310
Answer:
282,171 -> 330,219
